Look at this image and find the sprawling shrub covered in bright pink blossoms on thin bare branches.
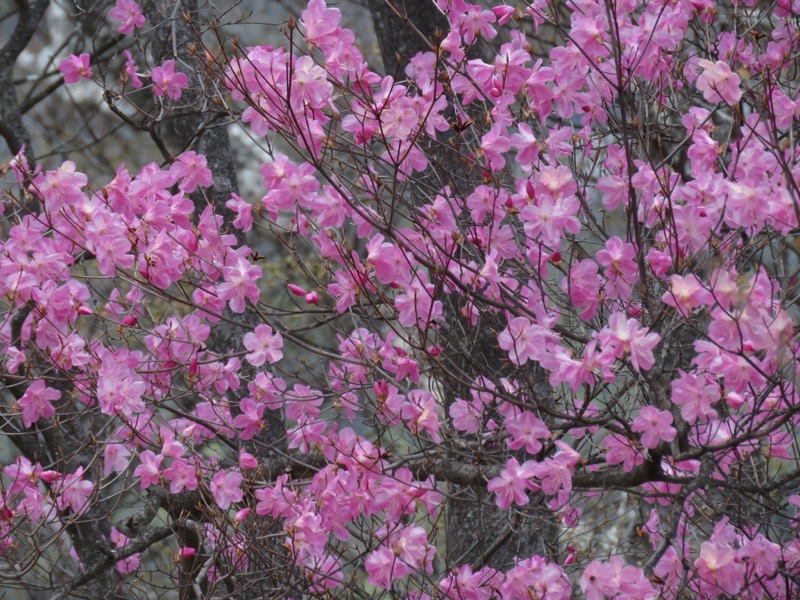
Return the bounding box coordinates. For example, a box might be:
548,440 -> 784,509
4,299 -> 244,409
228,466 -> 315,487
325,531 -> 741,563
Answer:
0,0 -> 800,599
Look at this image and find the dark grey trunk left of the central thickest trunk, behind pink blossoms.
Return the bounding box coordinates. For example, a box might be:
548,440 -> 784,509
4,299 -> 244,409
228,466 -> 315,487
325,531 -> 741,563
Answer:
146,0 -> 288,600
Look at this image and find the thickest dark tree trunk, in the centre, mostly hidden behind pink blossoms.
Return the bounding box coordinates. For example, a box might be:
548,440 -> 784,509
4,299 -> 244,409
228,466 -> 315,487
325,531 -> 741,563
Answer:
370,0 -> 558,568
